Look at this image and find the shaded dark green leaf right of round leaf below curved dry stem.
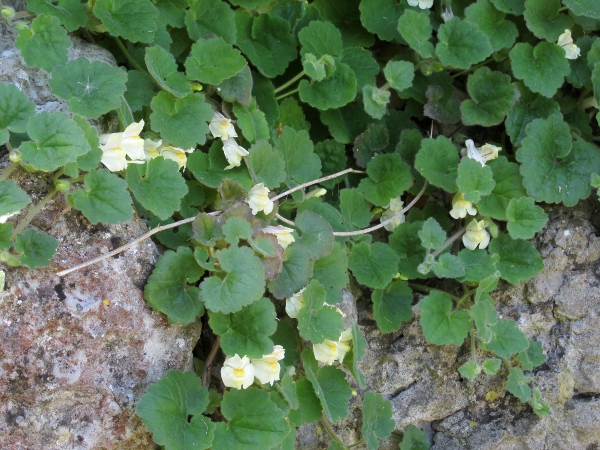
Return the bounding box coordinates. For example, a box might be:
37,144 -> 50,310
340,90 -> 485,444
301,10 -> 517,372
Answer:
389,222 -> 426,279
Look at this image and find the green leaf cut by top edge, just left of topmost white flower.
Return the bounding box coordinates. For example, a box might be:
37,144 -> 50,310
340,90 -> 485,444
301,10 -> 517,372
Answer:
359,0 -> 408,41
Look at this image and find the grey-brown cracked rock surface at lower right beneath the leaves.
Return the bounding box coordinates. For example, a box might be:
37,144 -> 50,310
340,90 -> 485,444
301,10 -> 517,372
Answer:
296,200 -> 600,450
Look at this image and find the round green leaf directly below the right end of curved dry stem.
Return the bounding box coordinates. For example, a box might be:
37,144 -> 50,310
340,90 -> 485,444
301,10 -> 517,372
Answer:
348,242 -> 398,289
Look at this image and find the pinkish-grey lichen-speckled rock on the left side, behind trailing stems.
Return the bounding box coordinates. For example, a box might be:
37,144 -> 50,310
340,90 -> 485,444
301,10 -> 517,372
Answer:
0,26 -> 200,450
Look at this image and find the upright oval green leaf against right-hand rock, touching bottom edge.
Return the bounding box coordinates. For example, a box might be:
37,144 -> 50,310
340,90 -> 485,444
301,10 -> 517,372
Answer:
361,391 -> 396,450
